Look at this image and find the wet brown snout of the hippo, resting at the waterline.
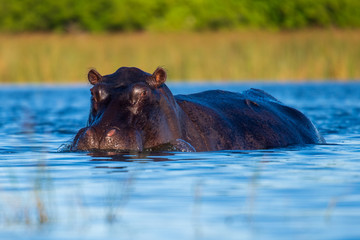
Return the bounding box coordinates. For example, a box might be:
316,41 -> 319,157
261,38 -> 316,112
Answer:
73,127 -> 143,151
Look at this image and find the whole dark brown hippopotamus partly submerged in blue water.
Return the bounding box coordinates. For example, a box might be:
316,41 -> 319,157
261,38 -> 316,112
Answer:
71,67 -> 325,152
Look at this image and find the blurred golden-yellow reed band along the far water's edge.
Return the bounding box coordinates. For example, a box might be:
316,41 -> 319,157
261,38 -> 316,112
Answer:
0,29 -> 360,83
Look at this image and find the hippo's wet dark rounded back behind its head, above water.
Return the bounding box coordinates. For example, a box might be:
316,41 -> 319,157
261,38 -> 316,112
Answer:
175,89 -> 324,150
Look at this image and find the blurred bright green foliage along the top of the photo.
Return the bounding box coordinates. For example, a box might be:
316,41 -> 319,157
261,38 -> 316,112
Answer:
0,0 -> 360,32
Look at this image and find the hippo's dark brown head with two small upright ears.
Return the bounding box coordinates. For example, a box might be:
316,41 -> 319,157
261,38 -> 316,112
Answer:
71,67 -> 181,151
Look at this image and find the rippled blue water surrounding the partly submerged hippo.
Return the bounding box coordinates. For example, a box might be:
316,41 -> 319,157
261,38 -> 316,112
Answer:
0,83 -> 360,240
